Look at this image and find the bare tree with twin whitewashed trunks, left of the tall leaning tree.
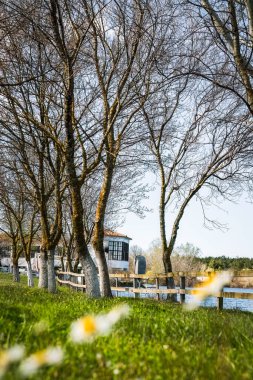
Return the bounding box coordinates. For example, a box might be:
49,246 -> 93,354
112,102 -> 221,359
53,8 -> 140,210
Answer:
1,84 -> 64,292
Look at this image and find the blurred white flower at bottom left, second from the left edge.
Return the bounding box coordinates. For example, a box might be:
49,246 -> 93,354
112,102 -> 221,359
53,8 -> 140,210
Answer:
20,347 -> 63,376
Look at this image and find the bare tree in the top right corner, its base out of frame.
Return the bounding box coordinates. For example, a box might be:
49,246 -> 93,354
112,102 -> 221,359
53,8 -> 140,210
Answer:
184,0 -> 253,113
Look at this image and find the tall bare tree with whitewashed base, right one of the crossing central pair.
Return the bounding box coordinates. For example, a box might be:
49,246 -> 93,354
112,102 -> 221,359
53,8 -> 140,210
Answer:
80,0 -> 177,297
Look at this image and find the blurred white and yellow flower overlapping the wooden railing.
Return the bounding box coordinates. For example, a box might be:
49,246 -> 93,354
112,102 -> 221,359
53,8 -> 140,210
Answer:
185,272 -> 233,310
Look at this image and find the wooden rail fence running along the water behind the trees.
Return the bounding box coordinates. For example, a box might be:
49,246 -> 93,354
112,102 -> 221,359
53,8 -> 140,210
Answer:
57,270 -> 253,310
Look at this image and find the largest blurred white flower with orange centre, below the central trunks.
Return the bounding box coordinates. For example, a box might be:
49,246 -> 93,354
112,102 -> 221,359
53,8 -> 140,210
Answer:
70,304 -> 130,343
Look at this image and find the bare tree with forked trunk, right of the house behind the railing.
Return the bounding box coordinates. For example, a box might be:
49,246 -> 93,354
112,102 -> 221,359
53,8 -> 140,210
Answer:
144,78 -> 252,287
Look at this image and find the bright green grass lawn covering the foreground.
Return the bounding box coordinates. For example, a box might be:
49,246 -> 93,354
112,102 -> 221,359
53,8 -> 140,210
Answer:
0,274 -> 253,380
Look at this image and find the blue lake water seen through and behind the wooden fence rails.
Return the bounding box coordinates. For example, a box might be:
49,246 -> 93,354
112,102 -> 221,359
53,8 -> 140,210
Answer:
113,286 -> 253,312
